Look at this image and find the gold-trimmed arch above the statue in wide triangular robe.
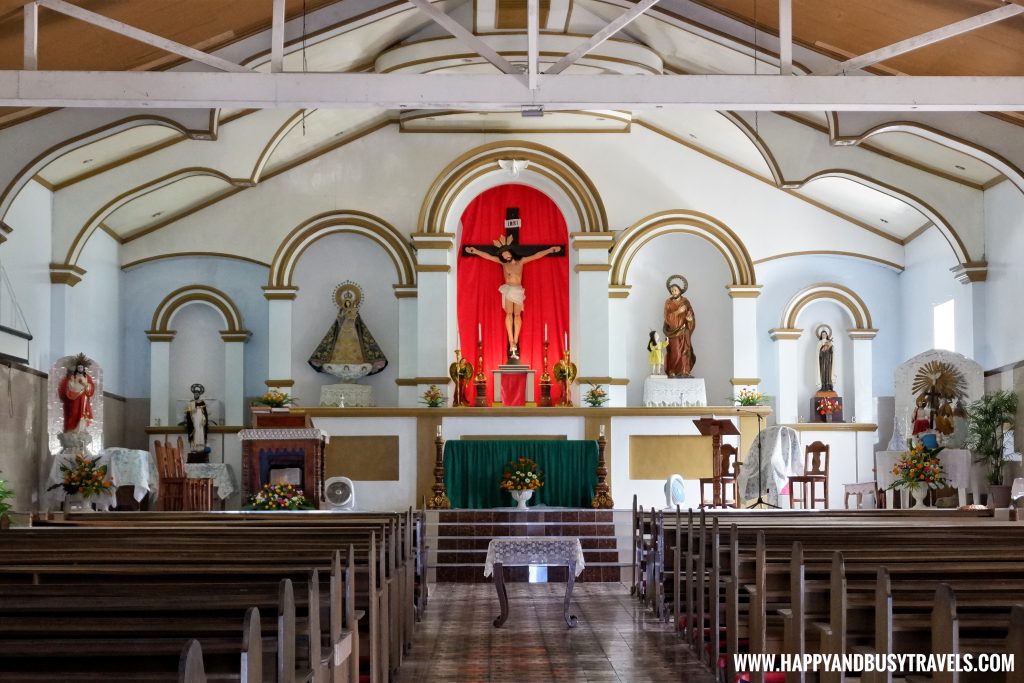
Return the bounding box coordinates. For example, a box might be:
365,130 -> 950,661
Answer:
267,211 -> 416,289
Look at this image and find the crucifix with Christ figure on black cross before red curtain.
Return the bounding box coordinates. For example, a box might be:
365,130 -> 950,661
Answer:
462,207 -> 565,360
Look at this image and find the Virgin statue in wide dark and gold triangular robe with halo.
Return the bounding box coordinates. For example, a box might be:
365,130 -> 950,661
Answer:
309,281 -> 387,382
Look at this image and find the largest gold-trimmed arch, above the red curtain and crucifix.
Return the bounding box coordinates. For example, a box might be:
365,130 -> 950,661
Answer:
419,140 -> 608,232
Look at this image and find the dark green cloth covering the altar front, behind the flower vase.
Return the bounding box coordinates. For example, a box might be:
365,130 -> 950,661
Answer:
444,440 -> 597,508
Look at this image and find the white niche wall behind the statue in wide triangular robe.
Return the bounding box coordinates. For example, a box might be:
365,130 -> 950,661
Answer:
292,234 -> 399,405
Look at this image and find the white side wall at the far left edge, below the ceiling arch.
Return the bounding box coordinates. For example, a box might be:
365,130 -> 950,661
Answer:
0,181 -> 54,373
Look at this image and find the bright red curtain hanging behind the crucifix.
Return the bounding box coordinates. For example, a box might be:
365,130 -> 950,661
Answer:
457,184 -> 569,403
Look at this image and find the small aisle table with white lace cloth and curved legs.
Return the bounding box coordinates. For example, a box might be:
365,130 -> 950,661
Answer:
483,537 -> 585,629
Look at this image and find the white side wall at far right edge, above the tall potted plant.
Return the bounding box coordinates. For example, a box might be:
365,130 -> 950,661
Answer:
977,182 -> 1024,369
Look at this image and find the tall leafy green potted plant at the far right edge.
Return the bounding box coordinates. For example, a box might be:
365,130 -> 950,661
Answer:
967,391 -> 1017,508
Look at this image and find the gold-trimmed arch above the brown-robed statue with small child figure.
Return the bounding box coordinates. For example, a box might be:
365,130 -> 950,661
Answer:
610,214 -> 758,287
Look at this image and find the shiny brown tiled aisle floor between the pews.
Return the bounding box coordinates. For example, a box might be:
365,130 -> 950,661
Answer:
398,584 -> 715,683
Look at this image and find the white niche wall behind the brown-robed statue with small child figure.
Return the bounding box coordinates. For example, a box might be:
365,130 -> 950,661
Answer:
618,233 -> 732,405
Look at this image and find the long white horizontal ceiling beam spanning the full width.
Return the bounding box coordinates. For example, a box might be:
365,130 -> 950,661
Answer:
0,71 -> 1024,112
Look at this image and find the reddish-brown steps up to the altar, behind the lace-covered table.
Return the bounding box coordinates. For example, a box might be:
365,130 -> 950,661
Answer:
426,508 -> 632,584
